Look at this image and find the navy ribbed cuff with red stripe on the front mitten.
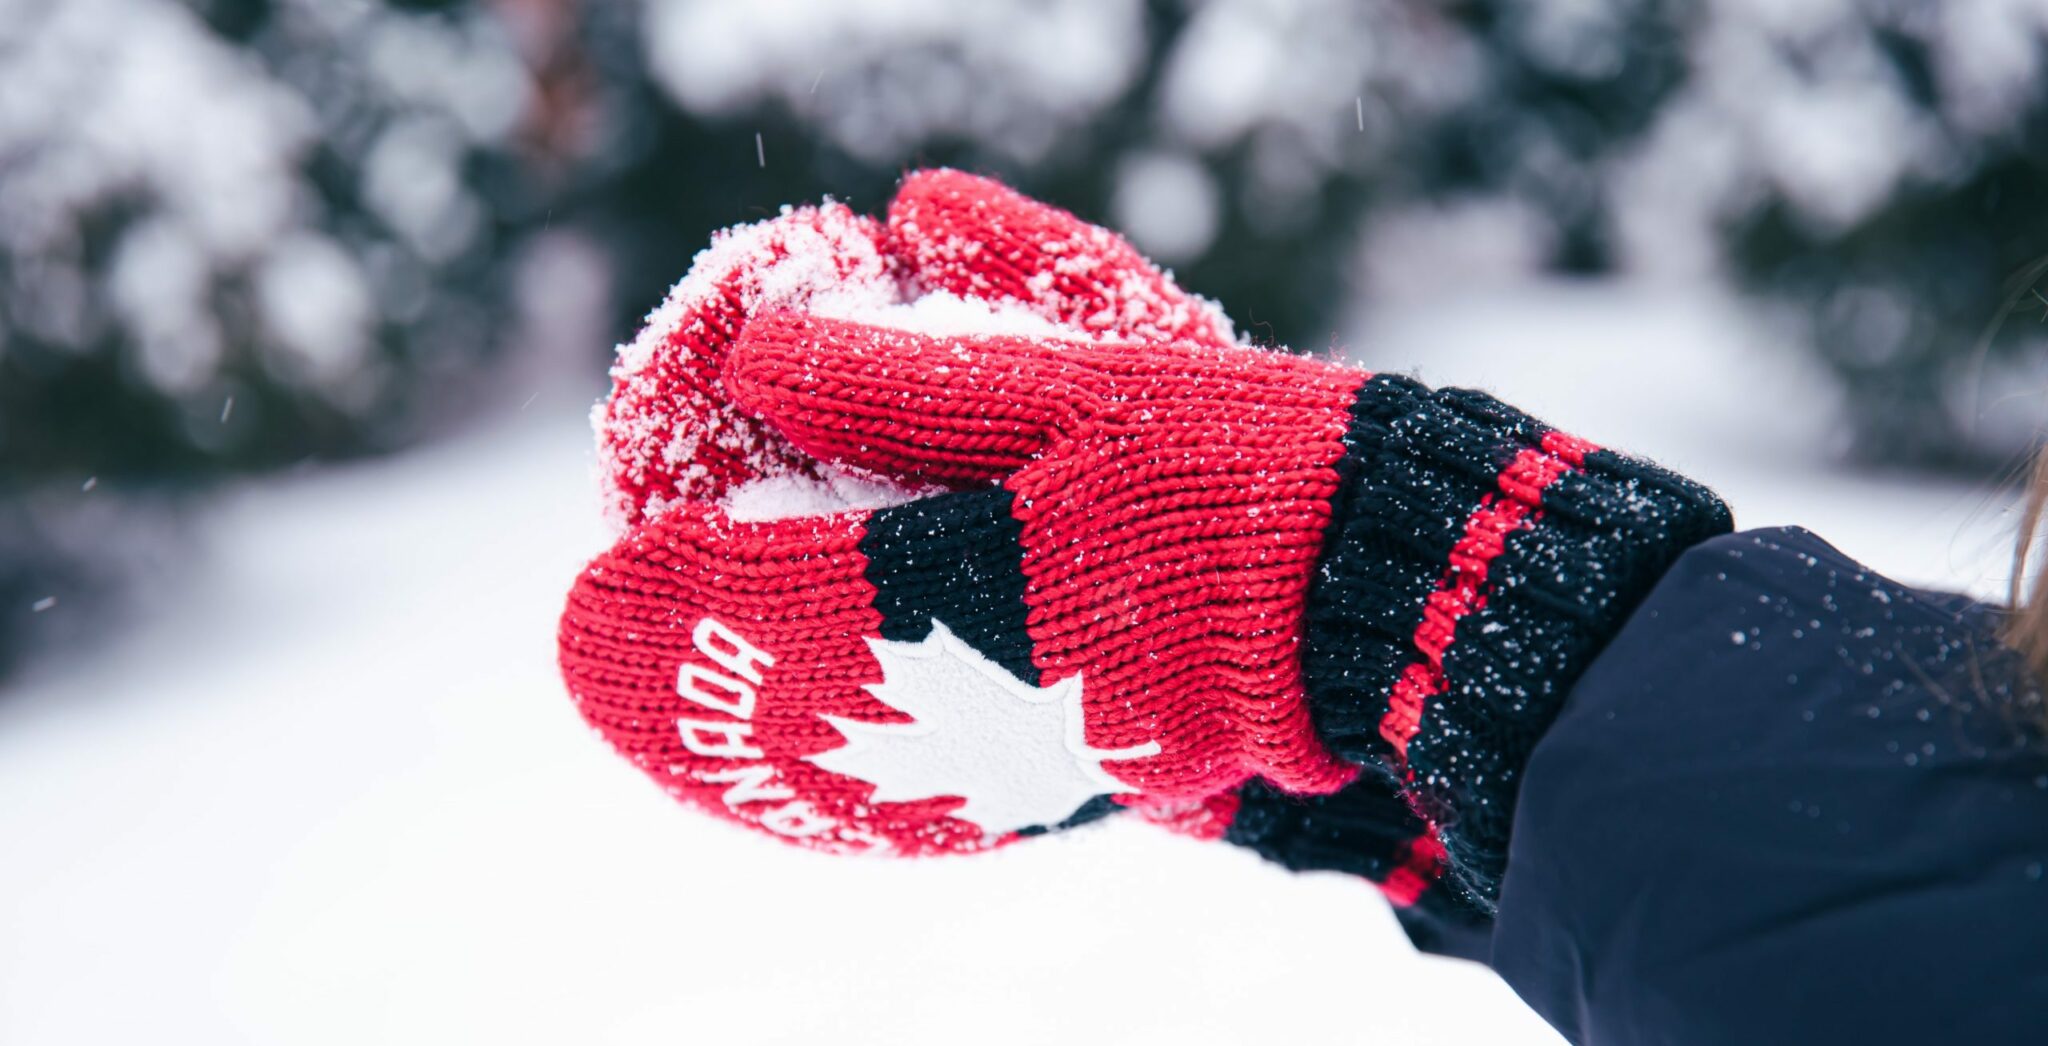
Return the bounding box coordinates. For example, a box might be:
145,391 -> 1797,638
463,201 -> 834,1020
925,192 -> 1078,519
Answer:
1303,375 -> 1733,911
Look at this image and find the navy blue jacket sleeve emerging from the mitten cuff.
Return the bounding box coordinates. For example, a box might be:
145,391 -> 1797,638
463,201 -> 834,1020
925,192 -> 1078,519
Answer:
1491,530 -> 2048,1046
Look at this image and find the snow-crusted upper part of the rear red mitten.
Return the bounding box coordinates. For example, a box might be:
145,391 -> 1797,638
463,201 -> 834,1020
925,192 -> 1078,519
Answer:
592,170 -> 1233,530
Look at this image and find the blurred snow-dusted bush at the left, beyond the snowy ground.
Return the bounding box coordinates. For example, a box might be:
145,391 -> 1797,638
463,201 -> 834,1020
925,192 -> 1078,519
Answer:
0,0 -> 545,669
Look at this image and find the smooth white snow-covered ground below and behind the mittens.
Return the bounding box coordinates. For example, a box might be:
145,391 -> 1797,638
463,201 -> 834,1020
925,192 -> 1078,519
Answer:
0,289 -> 2009,1046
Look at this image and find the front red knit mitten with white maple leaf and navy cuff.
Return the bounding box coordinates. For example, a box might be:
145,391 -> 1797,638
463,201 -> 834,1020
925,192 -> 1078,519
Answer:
563,313 -> 1729,899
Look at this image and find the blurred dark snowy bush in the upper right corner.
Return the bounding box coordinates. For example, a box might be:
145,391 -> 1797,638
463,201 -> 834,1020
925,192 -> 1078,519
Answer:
1703,0 -> 2048,471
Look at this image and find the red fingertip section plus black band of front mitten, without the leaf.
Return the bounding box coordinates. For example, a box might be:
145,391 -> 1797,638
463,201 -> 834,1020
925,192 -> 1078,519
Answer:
559,489 -> 1163,856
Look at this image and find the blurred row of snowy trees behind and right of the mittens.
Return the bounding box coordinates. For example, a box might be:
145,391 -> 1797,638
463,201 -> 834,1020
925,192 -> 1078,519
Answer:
618,0 -> 2048,467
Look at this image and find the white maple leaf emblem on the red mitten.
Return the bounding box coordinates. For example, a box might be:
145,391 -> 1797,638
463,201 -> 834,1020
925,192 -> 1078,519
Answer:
809,618 -> 1159,835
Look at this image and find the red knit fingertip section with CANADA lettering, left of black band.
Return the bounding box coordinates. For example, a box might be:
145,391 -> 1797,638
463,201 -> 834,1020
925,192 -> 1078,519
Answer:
559,512 -> 1011,854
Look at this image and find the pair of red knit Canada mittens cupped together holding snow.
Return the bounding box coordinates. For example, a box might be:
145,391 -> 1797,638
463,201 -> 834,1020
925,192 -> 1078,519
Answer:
561,172 -> 1729,911
